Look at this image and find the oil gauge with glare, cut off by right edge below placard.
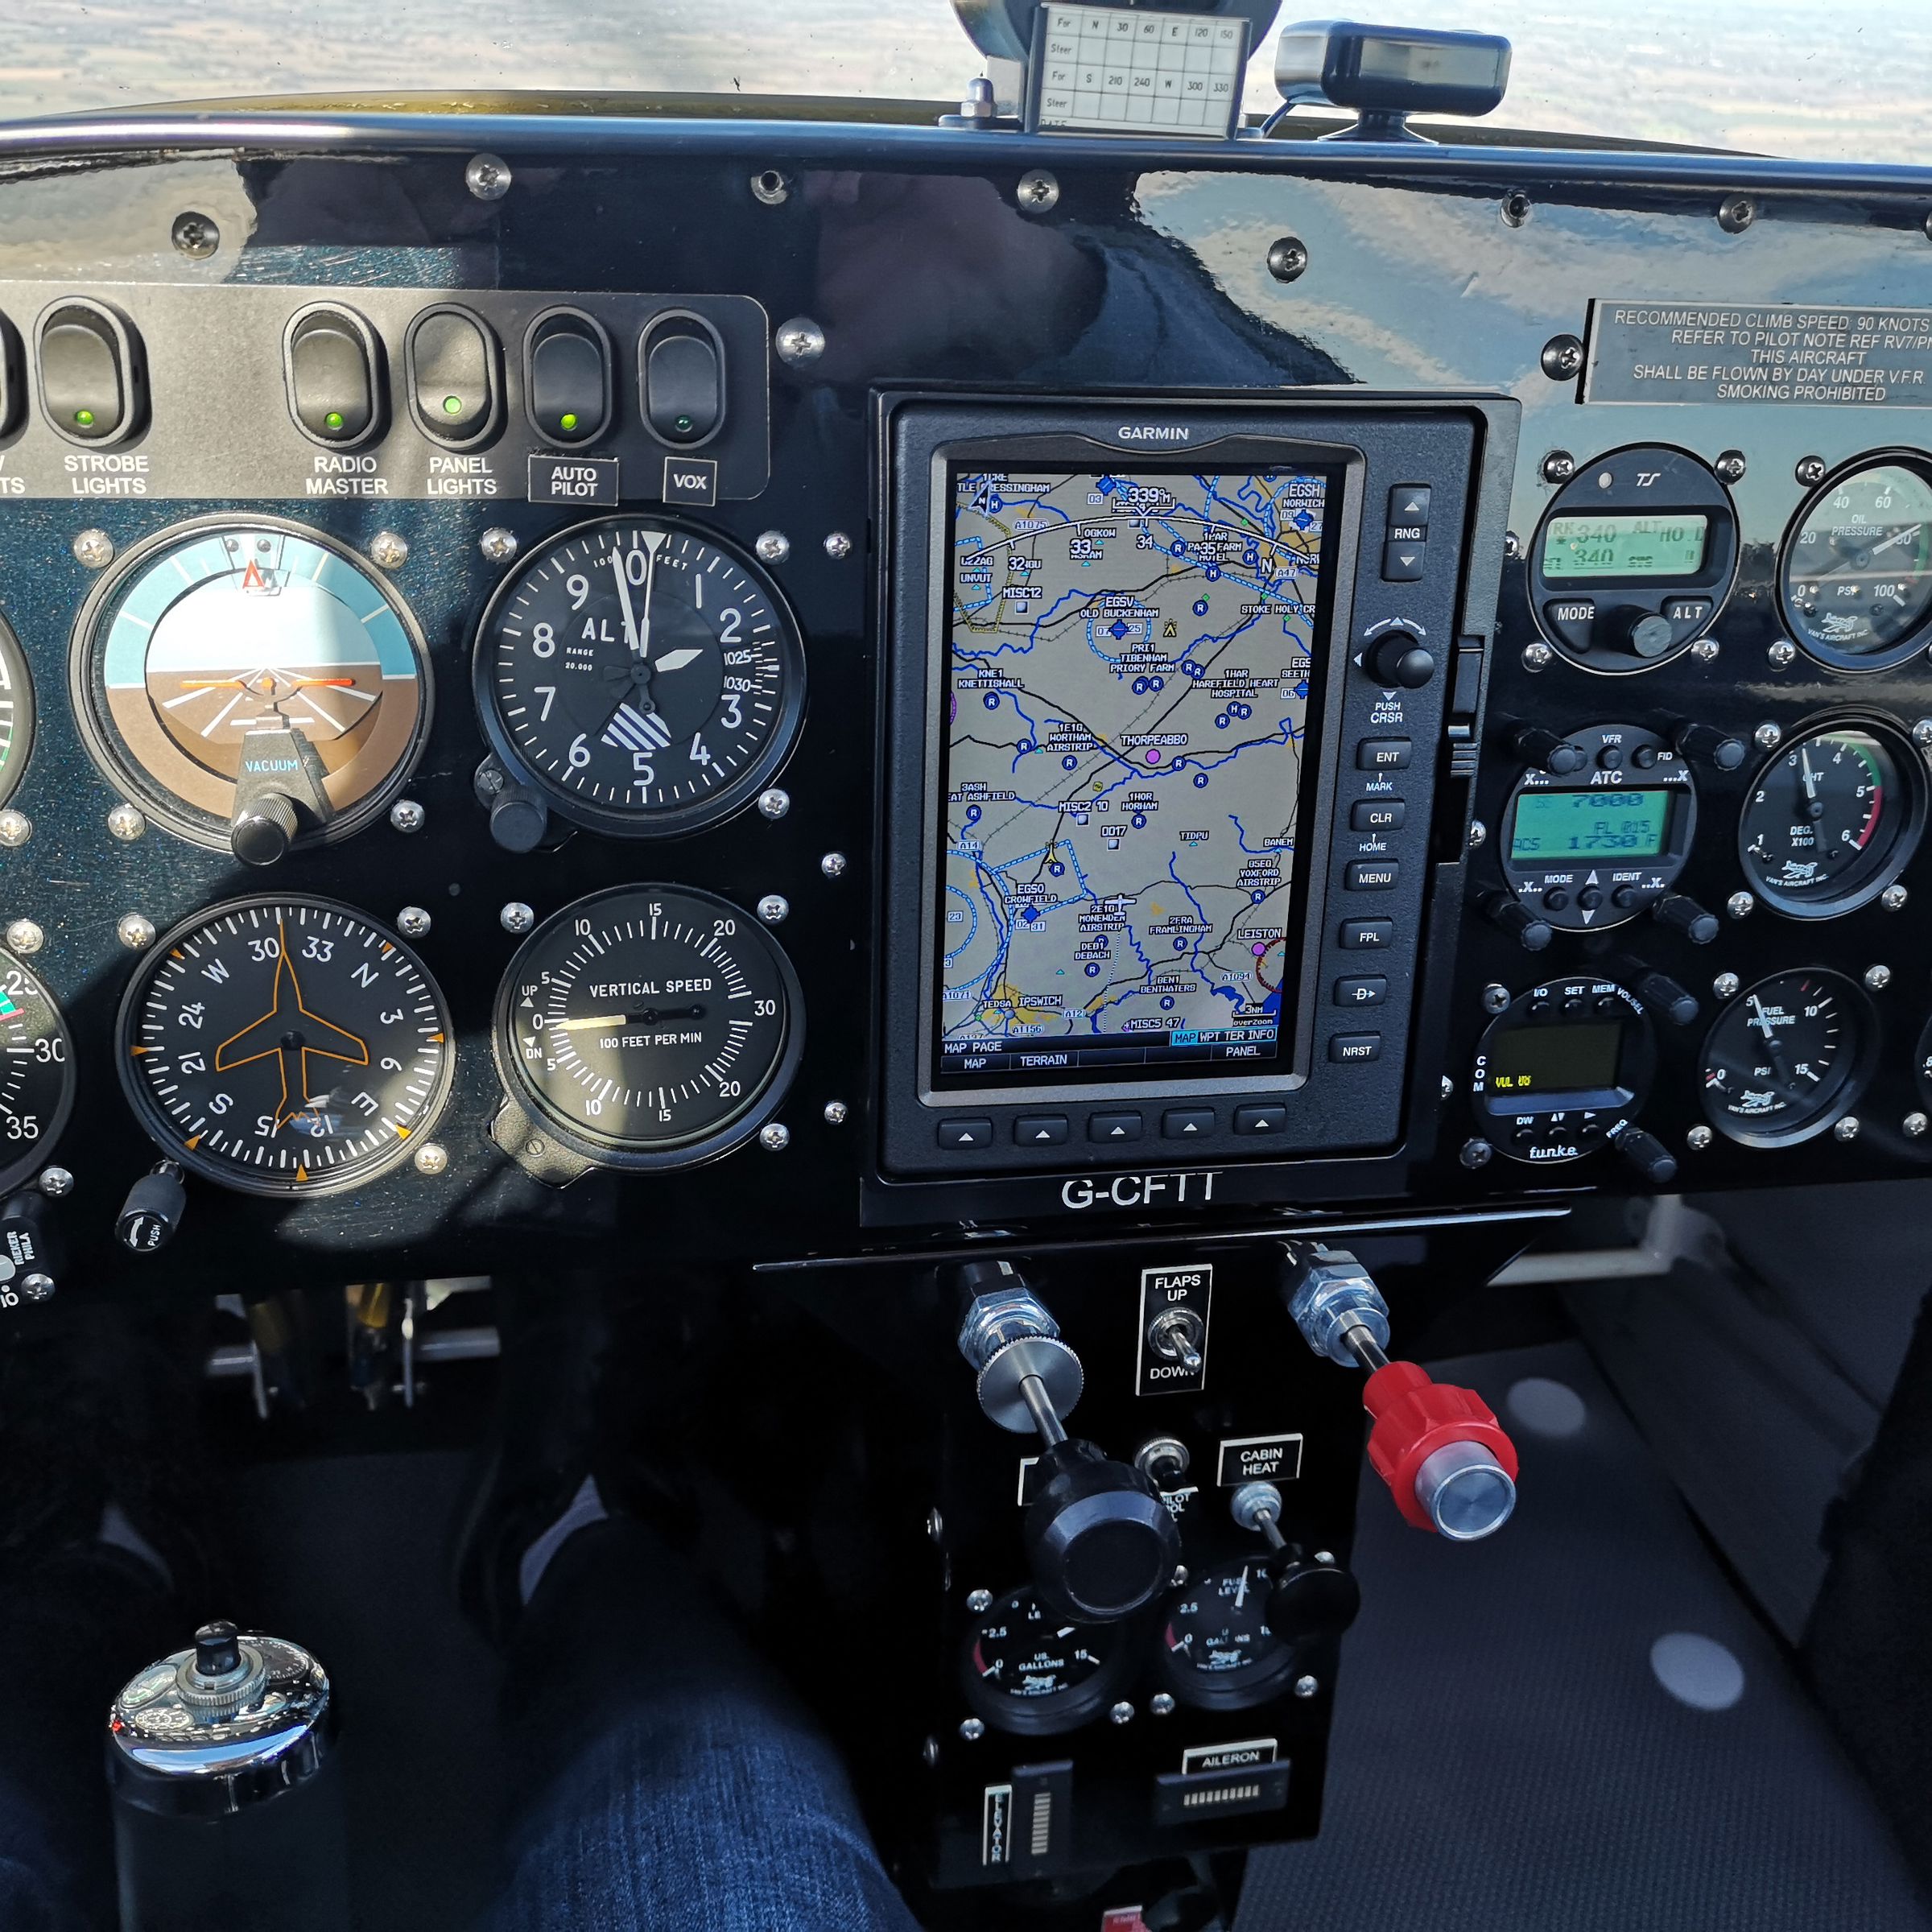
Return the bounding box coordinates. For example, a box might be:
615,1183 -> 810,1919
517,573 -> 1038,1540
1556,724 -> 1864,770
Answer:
1781,462 -> 1932,671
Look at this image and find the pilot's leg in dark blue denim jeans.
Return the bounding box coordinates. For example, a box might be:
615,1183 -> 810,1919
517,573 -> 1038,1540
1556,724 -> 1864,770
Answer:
491,1521 -> 916,1932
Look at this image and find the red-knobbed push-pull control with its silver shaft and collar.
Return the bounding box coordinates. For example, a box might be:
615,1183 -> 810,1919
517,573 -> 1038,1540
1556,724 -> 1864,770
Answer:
1281,1242 -> 1517,1544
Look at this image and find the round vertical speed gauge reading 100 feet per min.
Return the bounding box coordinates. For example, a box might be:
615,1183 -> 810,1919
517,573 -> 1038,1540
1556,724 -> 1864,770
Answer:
494,885 -> 803,1169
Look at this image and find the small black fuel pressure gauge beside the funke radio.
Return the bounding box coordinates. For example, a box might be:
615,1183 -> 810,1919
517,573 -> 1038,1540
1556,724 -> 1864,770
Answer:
1699,972 -> 1870,1148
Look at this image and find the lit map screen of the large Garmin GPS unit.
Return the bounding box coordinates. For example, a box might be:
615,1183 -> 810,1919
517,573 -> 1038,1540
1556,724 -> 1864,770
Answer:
935,464 -> 1335,1086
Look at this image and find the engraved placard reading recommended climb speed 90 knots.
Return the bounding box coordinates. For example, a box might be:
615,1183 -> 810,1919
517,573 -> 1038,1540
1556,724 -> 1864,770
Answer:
1583,301 -> 1932,410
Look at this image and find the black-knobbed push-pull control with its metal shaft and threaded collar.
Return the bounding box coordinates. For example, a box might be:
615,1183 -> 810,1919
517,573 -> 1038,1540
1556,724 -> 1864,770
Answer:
952,1261 -> 1180,1623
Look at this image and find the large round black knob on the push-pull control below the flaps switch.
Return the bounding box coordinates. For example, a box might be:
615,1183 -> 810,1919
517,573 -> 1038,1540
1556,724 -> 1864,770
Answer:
1022,1438 -> 1180,1623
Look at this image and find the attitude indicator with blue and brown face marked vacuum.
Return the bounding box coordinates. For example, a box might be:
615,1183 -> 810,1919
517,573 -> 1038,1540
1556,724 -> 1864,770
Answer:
72,518 -> 429,860
